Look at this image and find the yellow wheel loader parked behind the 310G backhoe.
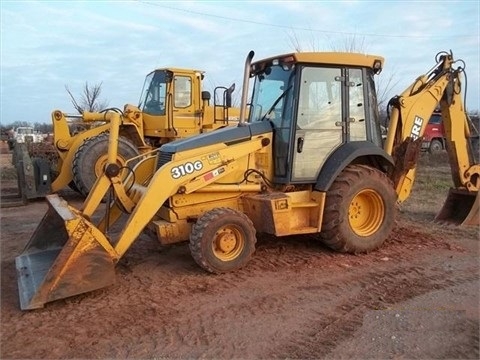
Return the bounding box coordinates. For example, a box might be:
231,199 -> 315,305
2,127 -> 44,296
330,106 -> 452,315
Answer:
17,68 -> 239,198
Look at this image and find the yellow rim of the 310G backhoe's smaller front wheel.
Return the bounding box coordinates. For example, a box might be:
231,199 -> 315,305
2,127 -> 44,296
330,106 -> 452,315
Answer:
212,225 -> 245,261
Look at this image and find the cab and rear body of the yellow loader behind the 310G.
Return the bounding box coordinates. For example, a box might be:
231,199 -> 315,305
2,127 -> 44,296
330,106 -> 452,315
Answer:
138,68 -> 238,142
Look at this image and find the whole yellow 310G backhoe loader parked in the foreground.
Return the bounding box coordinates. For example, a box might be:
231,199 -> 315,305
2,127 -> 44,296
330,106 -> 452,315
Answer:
16,52 -> 479,309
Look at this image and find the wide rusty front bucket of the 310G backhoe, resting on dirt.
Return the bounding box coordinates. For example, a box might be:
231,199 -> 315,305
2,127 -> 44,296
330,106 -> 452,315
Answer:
15,194 -> 117,310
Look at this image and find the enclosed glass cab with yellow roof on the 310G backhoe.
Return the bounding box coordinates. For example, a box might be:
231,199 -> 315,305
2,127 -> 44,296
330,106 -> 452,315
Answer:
249,53 -> 384,184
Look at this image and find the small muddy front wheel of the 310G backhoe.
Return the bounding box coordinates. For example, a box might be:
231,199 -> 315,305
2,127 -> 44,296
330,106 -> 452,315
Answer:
190,208 -> 257,274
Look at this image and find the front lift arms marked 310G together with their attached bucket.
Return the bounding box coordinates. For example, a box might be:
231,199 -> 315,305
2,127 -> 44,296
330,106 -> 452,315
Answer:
16,109 -> 271,309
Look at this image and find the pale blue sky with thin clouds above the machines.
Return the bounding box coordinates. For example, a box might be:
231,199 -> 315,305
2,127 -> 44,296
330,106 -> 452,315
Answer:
0,0 -> 480,125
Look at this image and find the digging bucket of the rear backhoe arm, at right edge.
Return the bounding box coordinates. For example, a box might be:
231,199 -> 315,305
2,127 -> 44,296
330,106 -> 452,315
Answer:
435,188 -> 480,226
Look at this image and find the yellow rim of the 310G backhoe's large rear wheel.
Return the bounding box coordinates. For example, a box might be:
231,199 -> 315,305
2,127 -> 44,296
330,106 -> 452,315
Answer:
348,189 -> 385,236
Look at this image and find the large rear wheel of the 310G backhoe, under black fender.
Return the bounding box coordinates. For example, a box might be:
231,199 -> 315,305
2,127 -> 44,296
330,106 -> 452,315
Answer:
320,165 -> 396,253
